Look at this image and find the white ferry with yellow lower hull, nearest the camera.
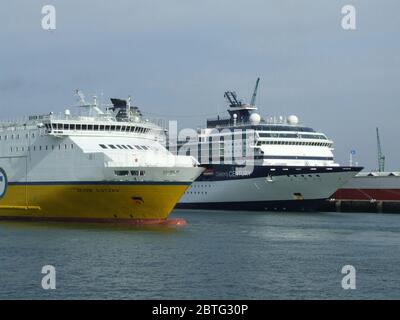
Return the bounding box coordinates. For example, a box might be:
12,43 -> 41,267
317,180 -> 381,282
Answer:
0,92 -> 204,223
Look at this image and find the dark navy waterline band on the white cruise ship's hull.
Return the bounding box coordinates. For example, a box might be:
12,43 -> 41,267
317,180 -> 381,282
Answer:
175,199 -> 326,212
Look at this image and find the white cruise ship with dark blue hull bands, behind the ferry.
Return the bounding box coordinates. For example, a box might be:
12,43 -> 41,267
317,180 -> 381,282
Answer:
170,79 -> 362,211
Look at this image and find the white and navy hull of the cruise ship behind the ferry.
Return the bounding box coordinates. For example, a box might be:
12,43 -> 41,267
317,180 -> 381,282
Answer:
177,166 -> 361,211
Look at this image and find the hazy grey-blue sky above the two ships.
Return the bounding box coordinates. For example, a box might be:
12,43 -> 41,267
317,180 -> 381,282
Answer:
0,0 -> 400,170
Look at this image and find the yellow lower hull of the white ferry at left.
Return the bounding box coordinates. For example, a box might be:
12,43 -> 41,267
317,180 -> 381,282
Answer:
0,183 -> 189,220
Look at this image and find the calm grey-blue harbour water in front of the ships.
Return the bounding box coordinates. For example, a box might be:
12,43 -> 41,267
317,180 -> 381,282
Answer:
0,211 -> 400,299
